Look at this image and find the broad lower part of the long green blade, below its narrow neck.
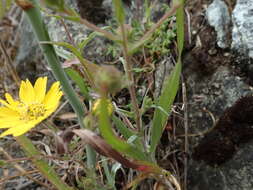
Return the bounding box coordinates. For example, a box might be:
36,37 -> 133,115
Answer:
150,62 -> 182,153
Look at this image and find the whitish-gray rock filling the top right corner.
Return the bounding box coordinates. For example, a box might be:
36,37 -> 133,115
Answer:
232,0 -> 253,58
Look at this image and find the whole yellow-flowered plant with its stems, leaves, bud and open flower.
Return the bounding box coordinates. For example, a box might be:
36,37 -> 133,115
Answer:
0,0 -> 184,190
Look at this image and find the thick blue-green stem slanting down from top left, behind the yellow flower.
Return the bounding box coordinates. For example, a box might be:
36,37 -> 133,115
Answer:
16,0 -> 96,168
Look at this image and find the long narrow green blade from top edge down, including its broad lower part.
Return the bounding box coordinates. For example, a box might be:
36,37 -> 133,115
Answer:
150,0 -> 184,154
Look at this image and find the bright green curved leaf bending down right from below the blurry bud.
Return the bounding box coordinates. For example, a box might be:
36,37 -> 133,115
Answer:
99,98 -> 147,161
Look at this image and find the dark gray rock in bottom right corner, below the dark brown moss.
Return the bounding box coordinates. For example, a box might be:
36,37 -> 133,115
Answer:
189,143 -> 253,190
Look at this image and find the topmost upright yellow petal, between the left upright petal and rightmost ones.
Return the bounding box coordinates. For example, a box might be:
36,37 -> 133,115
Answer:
34,77 -> 47,102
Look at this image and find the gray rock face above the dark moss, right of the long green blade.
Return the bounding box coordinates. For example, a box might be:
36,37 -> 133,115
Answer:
185,67 -> 251,133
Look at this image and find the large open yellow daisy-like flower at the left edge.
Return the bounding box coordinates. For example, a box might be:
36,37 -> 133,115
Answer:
0,77 -> 62,137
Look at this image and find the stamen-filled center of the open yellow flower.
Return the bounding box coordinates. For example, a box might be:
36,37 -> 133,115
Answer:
19,103 -> 46,121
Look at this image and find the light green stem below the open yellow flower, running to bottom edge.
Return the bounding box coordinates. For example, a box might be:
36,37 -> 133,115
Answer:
16,135 -> 73,190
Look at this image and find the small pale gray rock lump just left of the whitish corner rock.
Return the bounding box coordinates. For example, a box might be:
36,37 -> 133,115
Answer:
206,0 -> 230,48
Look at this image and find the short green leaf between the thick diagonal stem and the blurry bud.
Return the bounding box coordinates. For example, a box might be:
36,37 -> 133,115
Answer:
65,68 -> 90,99
